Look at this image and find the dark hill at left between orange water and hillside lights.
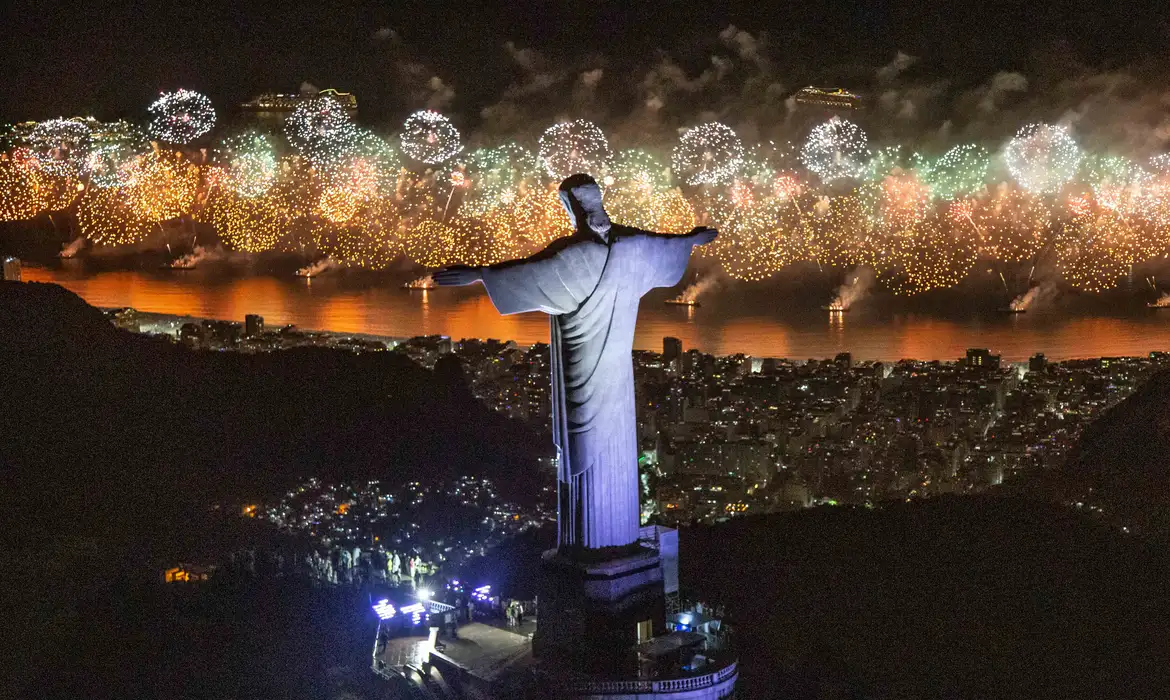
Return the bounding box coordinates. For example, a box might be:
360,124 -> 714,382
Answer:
0,283 -> 541,540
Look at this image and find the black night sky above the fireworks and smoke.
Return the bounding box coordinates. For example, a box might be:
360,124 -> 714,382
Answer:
0,0 -> 1170,129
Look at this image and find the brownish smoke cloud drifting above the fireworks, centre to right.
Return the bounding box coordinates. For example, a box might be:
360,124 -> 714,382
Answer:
379,25 -> 1170,160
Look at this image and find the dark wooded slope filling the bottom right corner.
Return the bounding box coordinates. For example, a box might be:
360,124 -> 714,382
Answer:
681,496 -> 1170,699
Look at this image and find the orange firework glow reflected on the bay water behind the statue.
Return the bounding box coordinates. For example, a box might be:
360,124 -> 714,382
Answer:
25,266 -> 1170,361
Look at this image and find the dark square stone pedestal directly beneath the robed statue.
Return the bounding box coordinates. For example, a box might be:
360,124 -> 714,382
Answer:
532,548 -> 666,674
